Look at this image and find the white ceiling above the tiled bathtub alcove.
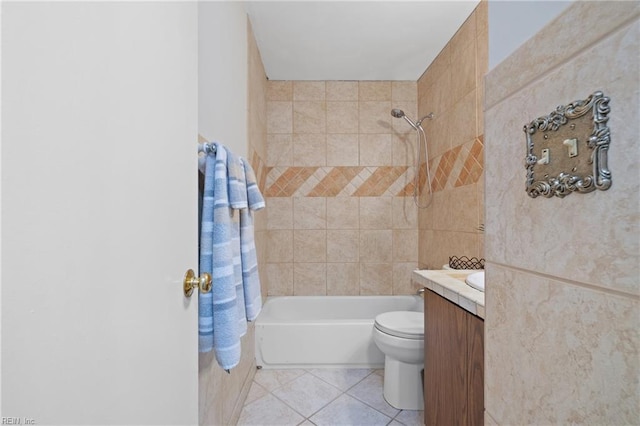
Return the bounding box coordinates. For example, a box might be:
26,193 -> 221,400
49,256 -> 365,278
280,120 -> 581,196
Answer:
245,0 -> 479,81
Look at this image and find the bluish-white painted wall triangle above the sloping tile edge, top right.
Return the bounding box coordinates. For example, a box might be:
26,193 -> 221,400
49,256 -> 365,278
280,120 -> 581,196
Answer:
489,0 -> 572,70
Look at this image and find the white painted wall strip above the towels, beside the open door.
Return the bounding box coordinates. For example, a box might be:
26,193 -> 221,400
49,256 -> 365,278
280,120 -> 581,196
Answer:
198,1 -> 247,156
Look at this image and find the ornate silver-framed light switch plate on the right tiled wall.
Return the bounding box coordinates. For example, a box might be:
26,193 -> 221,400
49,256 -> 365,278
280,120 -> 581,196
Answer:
524,92 -> 611,198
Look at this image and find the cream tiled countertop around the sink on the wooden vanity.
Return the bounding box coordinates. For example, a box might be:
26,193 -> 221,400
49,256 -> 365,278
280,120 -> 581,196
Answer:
411,269 -> 484,319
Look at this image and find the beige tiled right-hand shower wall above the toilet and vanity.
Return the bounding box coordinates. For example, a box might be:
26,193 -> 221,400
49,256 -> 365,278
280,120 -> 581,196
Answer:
418,1 -> 488,269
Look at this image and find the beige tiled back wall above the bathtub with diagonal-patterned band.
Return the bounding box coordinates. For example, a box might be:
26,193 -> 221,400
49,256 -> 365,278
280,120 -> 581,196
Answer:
265,81 -> 418,295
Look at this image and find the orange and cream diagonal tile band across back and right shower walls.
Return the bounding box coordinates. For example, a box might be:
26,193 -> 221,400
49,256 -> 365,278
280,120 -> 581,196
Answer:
262,137 -> 484,197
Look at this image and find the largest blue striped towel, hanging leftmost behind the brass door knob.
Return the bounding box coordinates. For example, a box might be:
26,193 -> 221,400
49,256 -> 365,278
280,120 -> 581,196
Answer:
198,143 -> 240,370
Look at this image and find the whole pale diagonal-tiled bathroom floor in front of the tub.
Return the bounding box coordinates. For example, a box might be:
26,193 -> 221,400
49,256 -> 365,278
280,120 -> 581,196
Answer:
238,368 -> 423,426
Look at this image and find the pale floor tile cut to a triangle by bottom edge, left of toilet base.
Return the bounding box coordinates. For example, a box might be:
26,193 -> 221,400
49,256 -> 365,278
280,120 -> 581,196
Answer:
309,394 -> 391,426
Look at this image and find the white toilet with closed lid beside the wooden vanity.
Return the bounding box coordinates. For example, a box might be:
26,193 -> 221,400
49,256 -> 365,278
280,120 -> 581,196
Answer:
373,311 -> 424,410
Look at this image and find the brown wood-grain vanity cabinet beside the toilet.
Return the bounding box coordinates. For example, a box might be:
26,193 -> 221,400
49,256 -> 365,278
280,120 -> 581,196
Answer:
424,289 -> 484,426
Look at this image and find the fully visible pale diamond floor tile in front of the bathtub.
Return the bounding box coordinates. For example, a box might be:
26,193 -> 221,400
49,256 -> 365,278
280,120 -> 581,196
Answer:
272,373 -> 342,417
